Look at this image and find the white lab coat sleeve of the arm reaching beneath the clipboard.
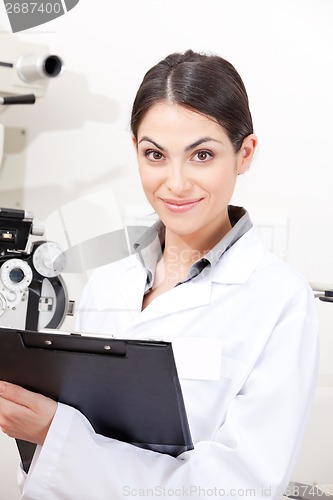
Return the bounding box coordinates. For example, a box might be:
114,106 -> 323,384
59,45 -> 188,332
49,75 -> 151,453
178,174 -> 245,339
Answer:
18,282 -> 318,500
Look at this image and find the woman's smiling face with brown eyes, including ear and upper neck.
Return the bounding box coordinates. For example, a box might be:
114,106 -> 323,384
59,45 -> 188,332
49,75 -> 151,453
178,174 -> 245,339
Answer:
134,103 -> 256,246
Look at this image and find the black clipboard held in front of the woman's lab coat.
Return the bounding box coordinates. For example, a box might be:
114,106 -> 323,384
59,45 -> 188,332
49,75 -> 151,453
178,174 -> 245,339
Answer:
0,328 -> 193,471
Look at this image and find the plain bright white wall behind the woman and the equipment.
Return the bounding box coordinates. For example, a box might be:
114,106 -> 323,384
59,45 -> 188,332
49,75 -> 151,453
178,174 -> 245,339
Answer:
0,0 -> 333,500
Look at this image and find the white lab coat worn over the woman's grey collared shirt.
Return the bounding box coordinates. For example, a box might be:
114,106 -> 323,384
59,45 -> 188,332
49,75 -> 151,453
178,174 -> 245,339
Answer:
22,228 -> 318,500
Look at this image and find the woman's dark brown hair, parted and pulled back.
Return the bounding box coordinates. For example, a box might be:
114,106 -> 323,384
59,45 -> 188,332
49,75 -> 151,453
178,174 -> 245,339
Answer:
131,50 -> 253,153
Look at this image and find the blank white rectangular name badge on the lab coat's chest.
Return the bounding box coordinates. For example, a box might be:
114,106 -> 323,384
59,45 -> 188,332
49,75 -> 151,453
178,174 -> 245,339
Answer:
170,337 -> 222,380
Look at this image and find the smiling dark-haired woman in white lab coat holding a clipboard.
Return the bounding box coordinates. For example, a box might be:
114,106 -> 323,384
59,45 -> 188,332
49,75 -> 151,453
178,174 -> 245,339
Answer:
0,51 -> 318,500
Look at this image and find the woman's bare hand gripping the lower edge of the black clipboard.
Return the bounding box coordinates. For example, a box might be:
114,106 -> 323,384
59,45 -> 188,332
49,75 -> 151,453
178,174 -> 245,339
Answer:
0,382 -> 57,445
